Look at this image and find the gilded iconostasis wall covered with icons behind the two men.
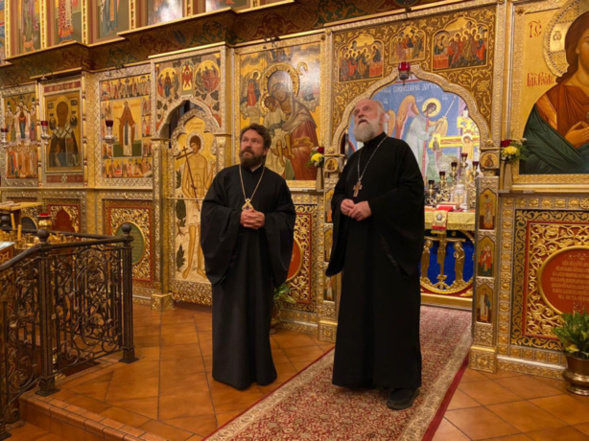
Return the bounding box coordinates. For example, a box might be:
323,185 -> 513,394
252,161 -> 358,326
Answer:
0,0 -> 589,370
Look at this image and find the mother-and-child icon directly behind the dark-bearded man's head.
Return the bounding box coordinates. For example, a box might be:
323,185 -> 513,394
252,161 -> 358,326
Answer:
236,43 -> 321,181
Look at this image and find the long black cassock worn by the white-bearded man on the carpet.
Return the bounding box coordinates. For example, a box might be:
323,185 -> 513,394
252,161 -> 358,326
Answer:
327,133 -> 425,389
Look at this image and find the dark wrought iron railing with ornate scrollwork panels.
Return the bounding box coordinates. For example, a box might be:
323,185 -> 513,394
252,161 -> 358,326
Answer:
0,225 -> 136,440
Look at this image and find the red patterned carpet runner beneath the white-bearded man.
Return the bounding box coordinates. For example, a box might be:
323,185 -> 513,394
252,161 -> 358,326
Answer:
206,306 -> 472,441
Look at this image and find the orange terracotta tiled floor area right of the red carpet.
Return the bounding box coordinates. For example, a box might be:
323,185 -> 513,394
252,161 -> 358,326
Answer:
433,369 -> 589,441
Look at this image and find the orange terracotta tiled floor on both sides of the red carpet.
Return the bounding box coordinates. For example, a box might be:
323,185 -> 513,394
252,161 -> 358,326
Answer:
11,305 -> 589,441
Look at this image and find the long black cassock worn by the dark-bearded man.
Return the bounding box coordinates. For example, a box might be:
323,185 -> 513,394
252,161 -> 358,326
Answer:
201,165 -> 296,389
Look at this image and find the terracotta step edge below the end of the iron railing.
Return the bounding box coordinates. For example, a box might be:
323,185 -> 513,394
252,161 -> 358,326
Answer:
19,391 -> 166,441
